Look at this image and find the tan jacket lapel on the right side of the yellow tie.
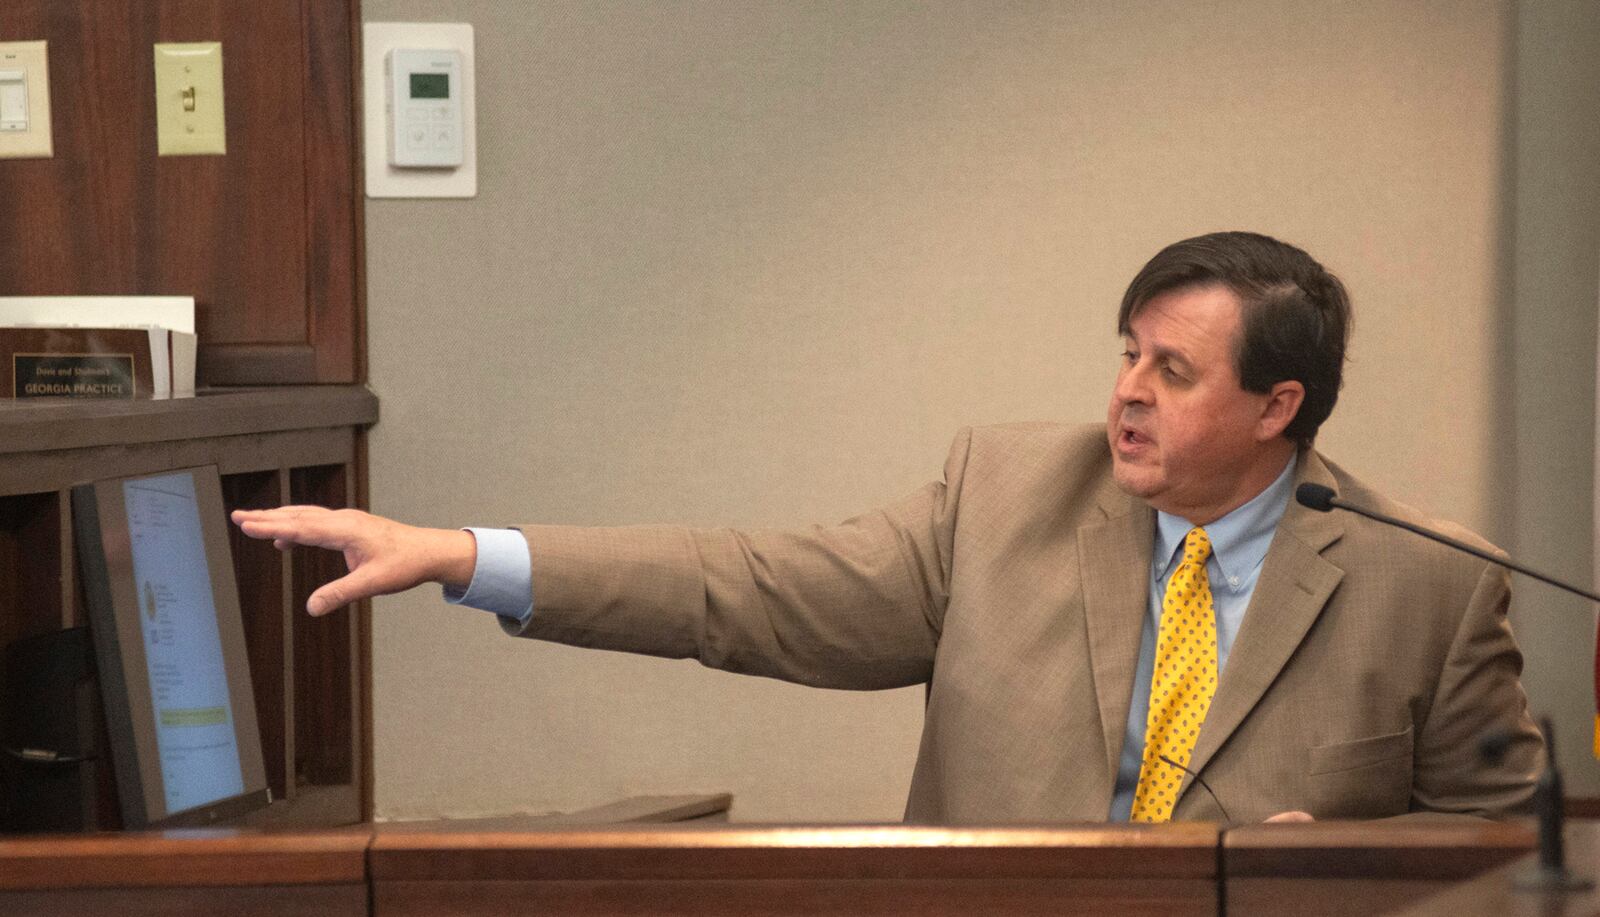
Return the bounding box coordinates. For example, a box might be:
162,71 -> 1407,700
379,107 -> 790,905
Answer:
1179,451 -> 1344,799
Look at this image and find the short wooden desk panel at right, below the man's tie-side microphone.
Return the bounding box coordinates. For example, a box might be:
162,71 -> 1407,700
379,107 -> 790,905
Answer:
1222,821 -> 1533,917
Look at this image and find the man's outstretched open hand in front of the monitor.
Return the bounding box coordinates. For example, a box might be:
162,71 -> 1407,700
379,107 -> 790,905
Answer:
232,506 -> 477,615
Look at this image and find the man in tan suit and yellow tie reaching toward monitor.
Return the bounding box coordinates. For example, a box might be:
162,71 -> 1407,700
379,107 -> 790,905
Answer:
235,232 -> 1541,823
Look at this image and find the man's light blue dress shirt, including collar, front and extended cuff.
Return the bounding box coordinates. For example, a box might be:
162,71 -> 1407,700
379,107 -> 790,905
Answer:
445,458 -> 1296,821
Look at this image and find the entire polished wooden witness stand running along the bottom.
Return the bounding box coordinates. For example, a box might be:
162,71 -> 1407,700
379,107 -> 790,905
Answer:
0,797 -> 1533,917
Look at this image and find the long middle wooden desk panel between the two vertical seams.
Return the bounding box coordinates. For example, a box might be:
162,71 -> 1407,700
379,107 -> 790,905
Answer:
370,824 -> 1218,917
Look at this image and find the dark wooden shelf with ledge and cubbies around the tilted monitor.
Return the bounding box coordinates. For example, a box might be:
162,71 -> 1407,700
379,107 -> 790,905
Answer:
0,386 -> 378,827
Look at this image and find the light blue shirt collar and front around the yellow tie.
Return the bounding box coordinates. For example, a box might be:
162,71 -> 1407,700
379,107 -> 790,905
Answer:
1109,458 -> 1296,821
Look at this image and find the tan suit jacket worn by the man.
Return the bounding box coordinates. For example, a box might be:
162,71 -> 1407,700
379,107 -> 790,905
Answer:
512,424 -> 1541,823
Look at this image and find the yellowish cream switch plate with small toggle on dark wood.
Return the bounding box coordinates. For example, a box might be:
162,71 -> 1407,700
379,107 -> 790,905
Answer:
155,42 -> 227,155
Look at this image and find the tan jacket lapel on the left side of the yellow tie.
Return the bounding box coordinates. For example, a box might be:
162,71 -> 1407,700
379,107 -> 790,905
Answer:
1078,480 -> 1155,775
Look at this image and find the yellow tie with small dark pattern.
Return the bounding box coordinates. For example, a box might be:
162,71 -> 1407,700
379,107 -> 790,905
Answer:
1130,528 -> 1216,821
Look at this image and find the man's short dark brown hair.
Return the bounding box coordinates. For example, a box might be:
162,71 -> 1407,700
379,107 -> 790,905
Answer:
1117,232 -> 1350,446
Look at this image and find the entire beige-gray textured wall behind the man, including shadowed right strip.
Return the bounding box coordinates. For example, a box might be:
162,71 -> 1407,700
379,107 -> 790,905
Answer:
363,0 -> 1600,821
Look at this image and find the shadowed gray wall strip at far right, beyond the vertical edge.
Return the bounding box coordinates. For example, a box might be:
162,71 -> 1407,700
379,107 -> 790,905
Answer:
1490,2 -> 1600,795
